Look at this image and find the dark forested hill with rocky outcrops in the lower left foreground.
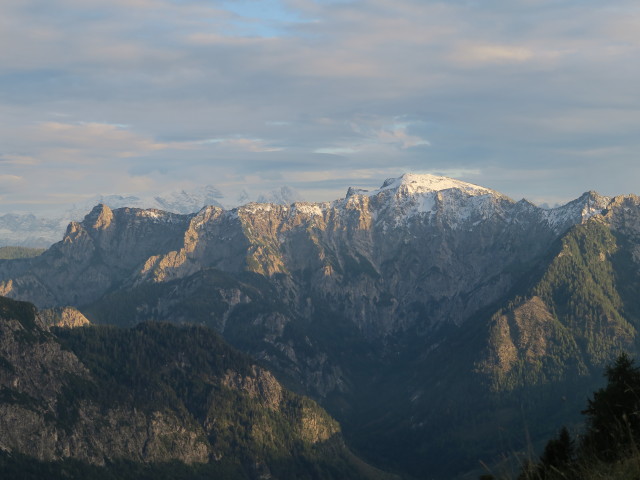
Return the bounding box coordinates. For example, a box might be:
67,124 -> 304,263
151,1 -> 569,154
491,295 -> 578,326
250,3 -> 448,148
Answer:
0,297 -> 385,479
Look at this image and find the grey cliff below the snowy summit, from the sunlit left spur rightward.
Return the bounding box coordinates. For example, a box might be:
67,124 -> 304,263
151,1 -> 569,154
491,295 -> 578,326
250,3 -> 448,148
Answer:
121,175 -> 608,337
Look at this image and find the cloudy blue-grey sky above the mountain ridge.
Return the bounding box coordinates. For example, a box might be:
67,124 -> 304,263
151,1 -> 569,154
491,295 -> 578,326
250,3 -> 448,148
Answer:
0,0 -> 640,212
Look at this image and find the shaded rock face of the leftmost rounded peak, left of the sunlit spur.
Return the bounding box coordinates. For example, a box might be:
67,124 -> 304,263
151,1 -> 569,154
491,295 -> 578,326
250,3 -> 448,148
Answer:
0,205 -> 189,308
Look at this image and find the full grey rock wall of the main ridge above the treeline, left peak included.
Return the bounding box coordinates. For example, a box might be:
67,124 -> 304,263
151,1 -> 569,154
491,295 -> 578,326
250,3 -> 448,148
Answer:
0,175 -> 608,337
